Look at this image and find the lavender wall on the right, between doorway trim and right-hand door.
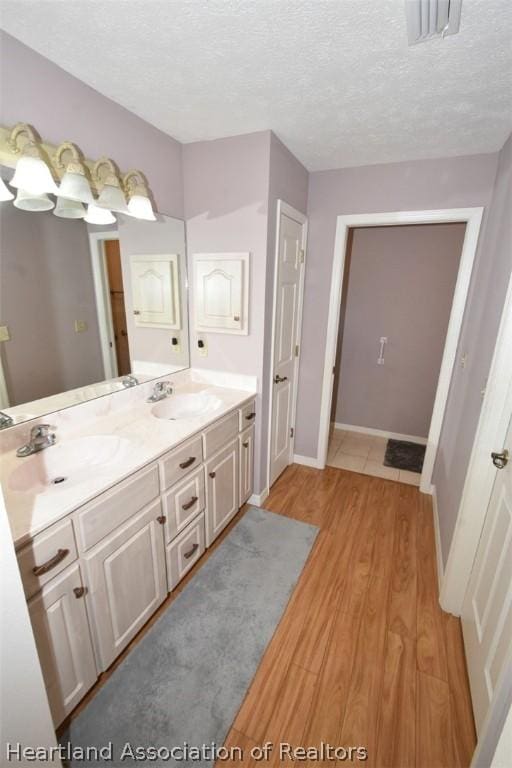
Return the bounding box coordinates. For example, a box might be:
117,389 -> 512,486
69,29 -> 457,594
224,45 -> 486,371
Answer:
433,136 -> 512,562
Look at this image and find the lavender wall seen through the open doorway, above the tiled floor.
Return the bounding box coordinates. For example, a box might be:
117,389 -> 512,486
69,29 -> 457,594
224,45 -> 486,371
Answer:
335,224 -> 465,437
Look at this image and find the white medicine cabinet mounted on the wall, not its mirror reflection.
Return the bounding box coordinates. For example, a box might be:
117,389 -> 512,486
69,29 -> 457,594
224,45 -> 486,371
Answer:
194,253 -> 249,334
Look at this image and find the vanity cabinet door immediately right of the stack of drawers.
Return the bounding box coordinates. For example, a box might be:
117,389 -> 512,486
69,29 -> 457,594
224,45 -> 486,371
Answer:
206,438 -> 239,547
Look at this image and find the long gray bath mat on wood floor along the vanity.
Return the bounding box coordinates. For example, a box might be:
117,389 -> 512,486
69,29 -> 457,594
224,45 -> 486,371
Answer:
61,507 -> 318,766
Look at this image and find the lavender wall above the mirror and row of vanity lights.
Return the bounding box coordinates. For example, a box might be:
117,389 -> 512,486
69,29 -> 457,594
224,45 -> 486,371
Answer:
0,31 -> 183,218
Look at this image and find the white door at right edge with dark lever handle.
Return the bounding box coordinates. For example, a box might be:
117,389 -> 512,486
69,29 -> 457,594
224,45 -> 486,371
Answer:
462,421 -> 512,731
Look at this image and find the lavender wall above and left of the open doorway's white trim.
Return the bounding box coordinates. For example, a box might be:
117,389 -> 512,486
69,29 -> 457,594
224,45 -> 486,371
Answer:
296,154 -> 497,457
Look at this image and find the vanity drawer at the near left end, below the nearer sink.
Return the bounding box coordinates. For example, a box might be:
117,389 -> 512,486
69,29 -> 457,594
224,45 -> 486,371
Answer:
17,517 -> 78,599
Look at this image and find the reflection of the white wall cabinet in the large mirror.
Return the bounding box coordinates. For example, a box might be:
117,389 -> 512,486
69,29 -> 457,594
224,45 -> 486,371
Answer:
130,253 -> 181,330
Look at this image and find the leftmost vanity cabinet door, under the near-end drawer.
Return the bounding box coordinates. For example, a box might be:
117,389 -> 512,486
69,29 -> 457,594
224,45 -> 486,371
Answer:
27,563 -> 97,728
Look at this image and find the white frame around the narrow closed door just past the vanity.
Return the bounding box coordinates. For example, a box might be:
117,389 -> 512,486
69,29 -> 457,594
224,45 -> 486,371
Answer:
266,198 -> 308,488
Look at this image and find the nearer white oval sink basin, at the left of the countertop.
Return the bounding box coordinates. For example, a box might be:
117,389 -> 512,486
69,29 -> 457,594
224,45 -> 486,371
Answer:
9,435 -> 133,494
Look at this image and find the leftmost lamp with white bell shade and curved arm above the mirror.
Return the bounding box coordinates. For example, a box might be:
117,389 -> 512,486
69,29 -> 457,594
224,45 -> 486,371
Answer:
9,123 -> 57,195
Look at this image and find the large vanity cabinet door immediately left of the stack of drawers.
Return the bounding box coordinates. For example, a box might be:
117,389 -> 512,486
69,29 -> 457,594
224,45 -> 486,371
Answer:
84,500 -> 167,671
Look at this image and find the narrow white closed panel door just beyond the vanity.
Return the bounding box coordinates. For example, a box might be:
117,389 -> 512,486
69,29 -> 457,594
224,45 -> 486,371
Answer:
270,204 -> 305,485
